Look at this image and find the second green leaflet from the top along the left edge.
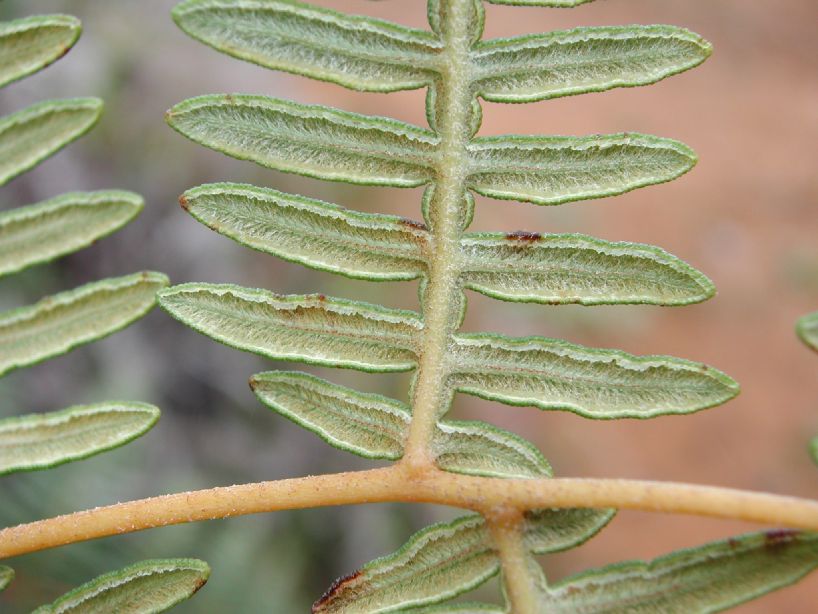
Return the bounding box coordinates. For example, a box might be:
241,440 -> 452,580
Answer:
0,98 -> 102,185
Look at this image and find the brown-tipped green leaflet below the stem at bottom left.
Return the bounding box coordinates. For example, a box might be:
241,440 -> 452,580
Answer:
33,559 -> 210,614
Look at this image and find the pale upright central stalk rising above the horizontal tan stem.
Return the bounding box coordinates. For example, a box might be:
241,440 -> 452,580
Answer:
404,0 -> 473,468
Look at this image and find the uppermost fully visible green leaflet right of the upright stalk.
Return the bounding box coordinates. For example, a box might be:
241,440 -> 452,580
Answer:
472,26 -> 712,102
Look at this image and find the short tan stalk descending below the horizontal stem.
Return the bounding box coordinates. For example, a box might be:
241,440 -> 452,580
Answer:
487,510 -> 539,614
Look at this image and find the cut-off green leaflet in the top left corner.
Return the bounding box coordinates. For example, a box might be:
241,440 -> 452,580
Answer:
0,15 -> 82,87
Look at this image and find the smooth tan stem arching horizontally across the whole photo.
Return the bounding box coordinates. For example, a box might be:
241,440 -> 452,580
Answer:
0,463 -> 818,558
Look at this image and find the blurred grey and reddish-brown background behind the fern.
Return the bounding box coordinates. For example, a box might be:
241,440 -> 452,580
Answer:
0,0 -> 818,614
